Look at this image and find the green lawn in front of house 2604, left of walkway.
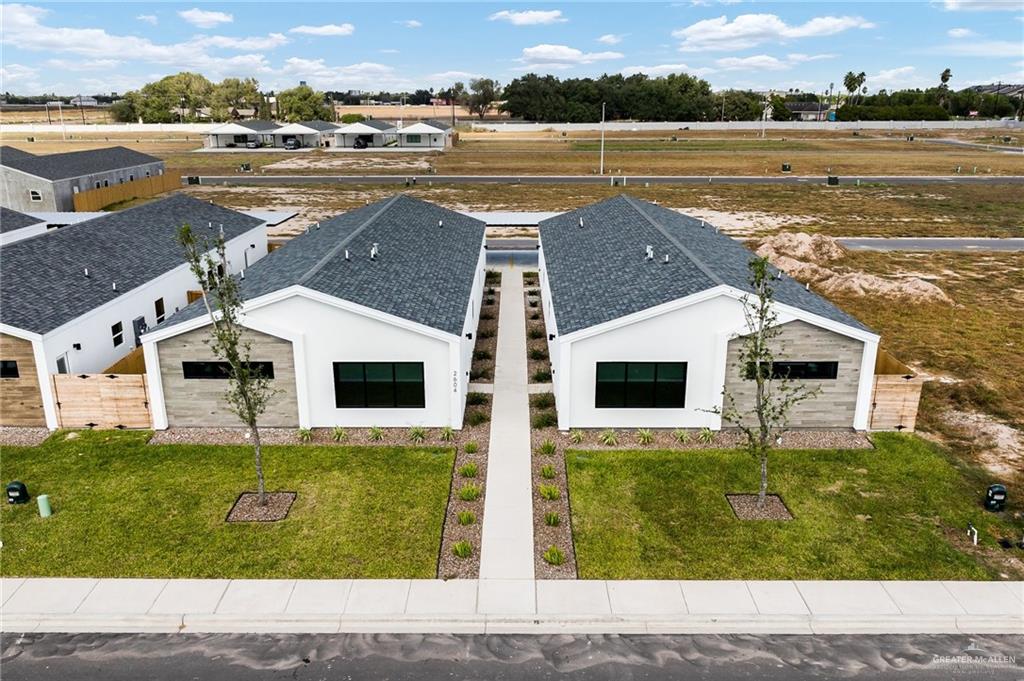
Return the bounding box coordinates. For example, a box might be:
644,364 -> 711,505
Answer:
0,431 -> 455,579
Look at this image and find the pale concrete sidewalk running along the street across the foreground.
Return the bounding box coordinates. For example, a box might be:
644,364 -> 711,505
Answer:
0,578 -> 1024,634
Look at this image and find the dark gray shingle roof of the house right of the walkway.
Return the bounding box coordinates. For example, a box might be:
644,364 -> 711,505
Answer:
540,195 -> 867,335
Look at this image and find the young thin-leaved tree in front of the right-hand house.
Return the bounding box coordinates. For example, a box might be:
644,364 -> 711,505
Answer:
712,258 -> 820,508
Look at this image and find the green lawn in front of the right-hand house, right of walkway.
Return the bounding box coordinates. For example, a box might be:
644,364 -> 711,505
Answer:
566,433 -> 1020,580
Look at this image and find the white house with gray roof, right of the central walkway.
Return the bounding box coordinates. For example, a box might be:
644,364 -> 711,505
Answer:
540,195 -> 879,430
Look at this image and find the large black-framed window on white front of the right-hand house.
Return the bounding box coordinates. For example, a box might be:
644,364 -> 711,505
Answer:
594,361 -> 686,409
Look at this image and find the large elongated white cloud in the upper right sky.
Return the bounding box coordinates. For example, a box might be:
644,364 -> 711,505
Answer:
672,14 -> 874,52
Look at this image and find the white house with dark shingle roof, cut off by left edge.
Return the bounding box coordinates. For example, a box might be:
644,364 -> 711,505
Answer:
0,195 -> 267,428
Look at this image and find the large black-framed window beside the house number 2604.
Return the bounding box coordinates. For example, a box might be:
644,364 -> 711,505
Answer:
334,361 -> 426,409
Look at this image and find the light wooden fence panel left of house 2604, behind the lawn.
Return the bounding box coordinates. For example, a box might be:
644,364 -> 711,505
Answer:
51,374 -> 153,428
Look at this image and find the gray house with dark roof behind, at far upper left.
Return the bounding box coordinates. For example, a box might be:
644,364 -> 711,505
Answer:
0,146 -> 164,212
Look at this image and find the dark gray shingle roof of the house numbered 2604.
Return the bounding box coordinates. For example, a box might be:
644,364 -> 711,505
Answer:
165,194 -> 485,335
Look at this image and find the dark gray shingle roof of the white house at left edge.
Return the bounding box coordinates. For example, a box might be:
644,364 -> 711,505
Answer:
0,194 -> 262,334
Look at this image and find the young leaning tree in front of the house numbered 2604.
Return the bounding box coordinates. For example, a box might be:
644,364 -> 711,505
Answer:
178,224 -> 275,506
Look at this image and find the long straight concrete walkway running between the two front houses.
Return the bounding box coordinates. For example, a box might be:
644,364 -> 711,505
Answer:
480,267 -> 534,580
